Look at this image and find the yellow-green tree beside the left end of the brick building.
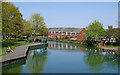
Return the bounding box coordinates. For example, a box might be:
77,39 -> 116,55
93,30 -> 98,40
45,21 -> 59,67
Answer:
30,14 -> 47,35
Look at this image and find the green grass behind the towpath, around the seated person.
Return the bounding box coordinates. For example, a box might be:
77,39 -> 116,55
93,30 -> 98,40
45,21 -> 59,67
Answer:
0,40 -> 34,56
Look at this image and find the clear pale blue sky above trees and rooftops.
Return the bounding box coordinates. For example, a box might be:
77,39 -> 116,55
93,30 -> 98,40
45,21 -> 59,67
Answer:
13,2 -> 118,29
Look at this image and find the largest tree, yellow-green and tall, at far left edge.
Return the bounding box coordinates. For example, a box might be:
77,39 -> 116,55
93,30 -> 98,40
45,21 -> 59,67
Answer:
2,2 -> 23,38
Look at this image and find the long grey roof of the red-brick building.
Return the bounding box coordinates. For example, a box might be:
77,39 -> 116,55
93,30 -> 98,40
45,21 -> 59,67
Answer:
48,28 -> 83,33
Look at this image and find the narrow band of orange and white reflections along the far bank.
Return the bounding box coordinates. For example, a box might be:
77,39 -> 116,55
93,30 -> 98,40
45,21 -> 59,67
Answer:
48,42 -> 116,56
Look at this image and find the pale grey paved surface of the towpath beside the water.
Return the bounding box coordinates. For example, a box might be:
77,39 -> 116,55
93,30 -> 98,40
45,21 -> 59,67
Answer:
0,43 -> 41,62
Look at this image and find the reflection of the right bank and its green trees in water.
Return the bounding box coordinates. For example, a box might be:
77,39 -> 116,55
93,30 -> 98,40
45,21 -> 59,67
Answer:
84,49 -> 118,72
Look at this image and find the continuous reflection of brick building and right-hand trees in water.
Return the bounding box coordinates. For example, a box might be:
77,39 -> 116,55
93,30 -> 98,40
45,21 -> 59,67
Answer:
48,42 -> 118,72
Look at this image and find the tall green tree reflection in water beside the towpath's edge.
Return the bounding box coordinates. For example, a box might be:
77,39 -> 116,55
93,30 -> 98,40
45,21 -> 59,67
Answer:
26,47 -> 47,73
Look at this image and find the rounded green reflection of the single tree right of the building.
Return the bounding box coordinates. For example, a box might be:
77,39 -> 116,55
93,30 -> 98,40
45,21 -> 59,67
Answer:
85,51 -> 104,72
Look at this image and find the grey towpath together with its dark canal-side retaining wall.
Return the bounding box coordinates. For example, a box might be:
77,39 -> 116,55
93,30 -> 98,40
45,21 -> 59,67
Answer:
0,43 -> 48,67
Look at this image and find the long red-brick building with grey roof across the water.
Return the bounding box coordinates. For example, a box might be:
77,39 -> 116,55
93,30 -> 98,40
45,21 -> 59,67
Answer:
48,28 -> 86,40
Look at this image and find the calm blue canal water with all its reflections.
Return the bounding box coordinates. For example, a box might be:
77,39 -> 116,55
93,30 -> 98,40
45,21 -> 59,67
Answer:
2,42 -> 118,73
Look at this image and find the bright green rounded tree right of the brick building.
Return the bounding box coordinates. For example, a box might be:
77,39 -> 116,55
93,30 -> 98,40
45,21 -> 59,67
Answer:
87,20 -> 106,41
